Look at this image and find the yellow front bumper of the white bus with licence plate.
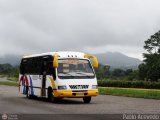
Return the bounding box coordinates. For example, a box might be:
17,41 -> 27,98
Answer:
54,90 -> 99,97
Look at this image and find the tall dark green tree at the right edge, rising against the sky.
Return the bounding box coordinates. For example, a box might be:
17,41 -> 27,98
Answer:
139,31 -> 160,81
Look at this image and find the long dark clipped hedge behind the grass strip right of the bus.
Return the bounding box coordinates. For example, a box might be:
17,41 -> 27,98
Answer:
98,80 -> 160,89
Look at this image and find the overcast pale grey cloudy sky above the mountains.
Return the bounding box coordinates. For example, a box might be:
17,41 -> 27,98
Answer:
0,0 -> 160,59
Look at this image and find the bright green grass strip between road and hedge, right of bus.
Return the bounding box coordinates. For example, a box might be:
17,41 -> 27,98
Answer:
98,87 -> 160,99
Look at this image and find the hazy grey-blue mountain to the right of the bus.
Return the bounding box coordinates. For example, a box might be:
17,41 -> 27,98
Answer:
95,52 -> 142,69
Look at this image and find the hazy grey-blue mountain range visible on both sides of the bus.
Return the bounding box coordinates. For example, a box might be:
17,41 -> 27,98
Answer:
0,52 -> 142,68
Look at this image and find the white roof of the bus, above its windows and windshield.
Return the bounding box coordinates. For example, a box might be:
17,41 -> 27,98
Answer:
23,51 -> 85,58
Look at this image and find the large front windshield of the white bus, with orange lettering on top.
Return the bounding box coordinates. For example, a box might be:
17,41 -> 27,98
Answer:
57,59 -> 95,79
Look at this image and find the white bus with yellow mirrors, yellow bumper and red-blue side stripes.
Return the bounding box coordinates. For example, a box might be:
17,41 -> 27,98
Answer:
18,52 -> 98,103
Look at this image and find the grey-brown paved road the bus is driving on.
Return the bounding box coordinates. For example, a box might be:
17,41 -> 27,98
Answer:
0,85 -> 160,114
